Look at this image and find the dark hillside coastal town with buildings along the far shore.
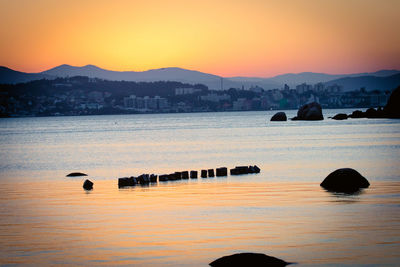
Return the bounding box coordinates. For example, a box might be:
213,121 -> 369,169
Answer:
0,76 -> 391,117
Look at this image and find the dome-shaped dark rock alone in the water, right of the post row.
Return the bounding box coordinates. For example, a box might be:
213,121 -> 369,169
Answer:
321,168 -> 369,193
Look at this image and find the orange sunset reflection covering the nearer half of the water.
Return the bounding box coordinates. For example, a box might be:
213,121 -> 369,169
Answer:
0,179 -> 400,266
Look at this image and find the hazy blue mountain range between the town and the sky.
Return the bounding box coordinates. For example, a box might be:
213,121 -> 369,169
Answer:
0,65 -> 400,91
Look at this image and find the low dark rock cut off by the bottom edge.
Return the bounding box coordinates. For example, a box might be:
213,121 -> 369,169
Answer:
210,253 -> 291,267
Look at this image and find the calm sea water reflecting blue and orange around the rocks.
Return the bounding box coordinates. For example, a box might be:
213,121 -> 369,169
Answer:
0,110 -> 400,266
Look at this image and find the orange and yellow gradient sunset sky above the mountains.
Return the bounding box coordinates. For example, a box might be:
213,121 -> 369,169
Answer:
0,0 -> 400,77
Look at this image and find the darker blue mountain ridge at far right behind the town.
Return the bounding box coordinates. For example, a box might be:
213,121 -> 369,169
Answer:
325,73 -> 400,91
